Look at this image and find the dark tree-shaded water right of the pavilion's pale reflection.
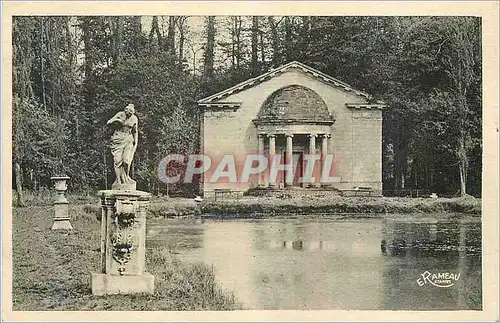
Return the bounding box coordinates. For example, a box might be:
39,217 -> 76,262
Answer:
380,219 -> 482,310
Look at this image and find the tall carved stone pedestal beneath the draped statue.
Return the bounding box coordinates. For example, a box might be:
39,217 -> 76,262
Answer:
91,190 -> 154,295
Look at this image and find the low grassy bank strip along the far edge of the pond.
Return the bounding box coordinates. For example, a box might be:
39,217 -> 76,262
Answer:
12,194 -> 481,218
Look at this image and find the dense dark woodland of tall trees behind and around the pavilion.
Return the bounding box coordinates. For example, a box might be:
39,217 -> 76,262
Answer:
13,16 -> 482,201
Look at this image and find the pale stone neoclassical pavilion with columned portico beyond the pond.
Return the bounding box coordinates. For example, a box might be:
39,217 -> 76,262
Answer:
198,62 -> 384,196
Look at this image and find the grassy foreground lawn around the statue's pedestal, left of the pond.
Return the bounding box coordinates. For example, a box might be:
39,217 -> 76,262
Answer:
12,205 -> 241,311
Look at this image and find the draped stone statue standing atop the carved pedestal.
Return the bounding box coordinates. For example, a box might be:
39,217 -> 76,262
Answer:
107,104 -> 139,190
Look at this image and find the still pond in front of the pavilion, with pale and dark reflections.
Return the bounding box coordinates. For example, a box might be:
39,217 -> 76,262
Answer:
147,215 -> 482,310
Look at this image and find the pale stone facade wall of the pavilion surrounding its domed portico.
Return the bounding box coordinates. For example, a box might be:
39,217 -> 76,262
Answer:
202,69 -> 382,192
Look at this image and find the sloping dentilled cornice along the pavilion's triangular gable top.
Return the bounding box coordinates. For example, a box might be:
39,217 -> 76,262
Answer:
197,61 -> 371,104
